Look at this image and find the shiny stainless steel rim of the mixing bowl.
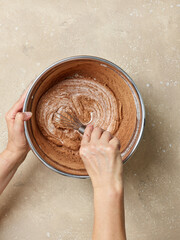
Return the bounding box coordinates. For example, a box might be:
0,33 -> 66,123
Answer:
23,55 -> 145,178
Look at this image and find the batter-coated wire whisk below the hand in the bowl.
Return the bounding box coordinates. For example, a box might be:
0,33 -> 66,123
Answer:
55,112 -> 86,134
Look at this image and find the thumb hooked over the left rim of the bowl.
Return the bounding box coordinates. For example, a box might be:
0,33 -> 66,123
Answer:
14,112 -> 32,134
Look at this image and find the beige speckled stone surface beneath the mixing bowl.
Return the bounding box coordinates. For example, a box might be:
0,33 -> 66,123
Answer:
0,0 -> 180,240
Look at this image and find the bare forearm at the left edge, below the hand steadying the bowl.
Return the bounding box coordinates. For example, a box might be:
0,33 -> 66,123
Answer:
0,149 -> 26,194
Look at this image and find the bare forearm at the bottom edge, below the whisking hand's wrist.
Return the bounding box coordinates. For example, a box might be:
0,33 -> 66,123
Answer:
93,188 -> 126,240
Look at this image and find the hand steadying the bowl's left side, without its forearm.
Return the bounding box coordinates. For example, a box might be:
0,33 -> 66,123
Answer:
6,89 -> 32,161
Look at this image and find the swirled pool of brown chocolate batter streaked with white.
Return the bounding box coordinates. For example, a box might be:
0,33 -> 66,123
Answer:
36,77 -> 121,151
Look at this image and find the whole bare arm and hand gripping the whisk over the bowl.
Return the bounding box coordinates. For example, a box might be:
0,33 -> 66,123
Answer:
80,126 -> 126,240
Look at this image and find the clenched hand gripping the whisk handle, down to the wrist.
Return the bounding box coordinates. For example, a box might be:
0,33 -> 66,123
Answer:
80,125 -> 123,191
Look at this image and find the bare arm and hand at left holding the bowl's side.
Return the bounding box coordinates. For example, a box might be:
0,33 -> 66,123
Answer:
0,91 -> 32,194
